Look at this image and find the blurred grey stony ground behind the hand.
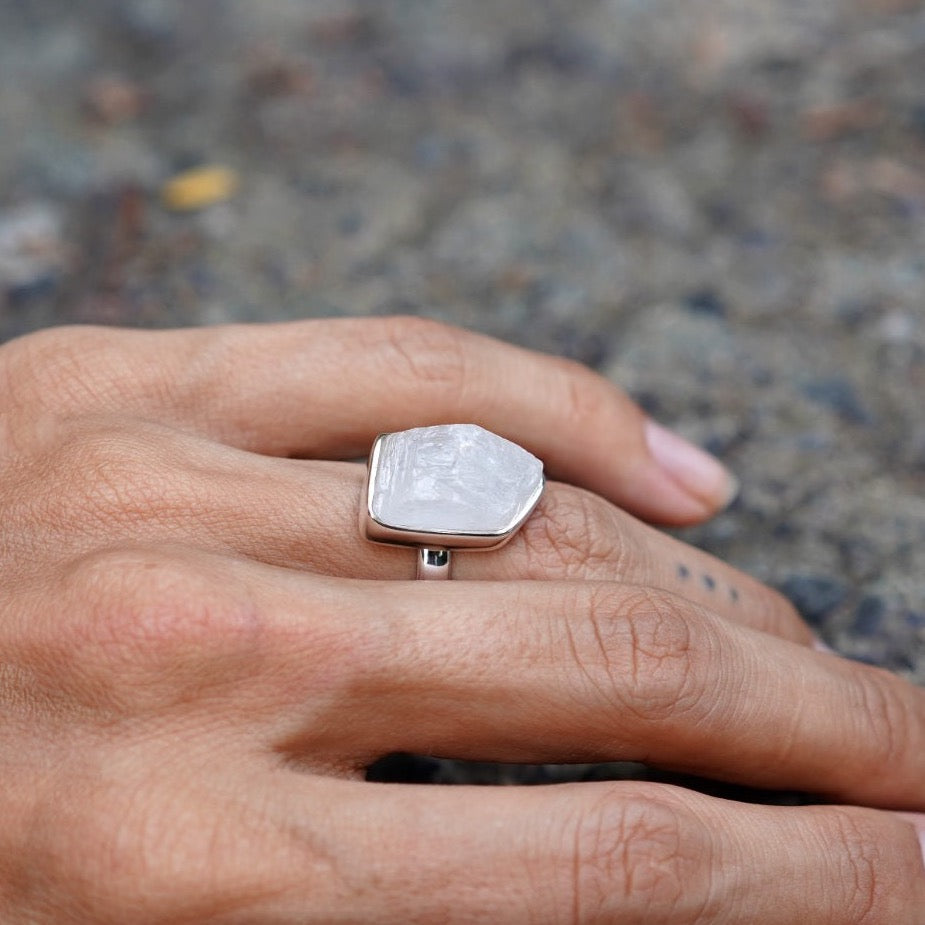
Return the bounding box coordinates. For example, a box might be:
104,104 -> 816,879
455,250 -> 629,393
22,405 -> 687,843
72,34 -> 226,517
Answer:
0,0 -> 925,681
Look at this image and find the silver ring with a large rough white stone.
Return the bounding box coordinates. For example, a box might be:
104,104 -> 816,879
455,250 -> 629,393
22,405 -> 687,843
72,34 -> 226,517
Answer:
360,424 -> 545,579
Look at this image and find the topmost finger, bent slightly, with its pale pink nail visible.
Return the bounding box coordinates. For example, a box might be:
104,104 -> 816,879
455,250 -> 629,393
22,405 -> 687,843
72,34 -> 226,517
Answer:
3,318 -> 736,524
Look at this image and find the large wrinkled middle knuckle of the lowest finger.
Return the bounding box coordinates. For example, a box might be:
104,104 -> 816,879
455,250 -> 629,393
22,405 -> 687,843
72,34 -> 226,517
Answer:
572,790 -> 712,925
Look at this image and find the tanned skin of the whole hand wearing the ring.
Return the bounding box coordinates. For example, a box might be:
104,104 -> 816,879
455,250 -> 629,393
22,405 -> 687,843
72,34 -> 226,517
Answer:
0,319 -> 925,925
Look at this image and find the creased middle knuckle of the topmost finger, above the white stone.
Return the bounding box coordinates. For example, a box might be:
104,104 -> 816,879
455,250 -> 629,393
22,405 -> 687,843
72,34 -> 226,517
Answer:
373,316 -> 467,398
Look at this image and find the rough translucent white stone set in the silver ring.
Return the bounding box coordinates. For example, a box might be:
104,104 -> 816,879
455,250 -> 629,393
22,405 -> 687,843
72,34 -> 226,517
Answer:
370,424 -> 543,534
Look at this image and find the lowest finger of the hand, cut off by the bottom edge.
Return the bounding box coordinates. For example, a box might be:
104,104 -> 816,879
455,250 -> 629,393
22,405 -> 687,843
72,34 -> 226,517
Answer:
262,773 -> 925,925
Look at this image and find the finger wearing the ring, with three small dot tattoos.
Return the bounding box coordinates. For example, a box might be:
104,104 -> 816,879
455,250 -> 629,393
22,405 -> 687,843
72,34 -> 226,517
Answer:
322,467 -> 796,645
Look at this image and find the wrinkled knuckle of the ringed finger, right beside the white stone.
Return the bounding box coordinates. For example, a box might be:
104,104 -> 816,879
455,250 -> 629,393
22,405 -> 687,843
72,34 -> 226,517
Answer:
516,484 -> 630,580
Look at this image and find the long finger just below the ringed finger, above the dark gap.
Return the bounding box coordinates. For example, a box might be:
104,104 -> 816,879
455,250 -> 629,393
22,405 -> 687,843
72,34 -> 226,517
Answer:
266,573 -> 925,810
